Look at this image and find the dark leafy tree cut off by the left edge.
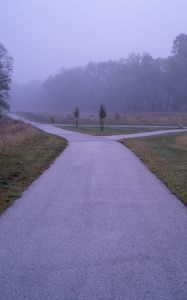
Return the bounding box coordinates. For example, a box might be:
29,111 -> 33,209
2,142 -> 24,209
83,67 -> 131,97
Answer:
0,44 -> 13,115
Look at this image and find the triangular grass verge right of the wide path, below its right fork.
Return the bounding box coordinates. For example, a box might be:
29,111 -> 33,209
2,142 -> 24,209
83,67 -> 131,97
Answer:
121,133 -> 187,205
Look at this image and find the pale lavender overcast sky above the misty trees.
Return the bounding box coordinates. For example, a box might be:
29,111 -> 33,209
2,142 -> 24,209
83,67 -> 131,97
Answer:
0,0 -> 187,83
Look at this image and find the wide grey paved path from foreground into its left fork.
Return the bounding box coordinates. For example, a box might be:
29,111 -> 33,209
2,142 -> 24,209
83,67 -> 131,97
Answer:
0,116 -> 187,300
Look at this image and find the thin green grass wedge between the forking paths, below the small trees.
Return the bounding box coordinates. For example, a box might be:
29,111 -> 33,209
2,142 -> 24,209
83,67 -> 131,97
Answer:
58,126 -> 175,136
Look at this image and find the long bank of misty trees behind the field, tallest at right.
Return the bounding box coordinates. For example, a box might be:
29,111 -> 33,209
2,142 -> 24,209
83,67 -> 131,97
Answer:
43,34 -> 187,112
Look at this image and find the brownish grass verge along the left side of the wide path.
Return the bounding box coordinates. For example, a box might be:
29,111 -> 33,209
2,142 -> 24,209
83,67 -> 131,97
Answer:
0,120 -> 67,213
